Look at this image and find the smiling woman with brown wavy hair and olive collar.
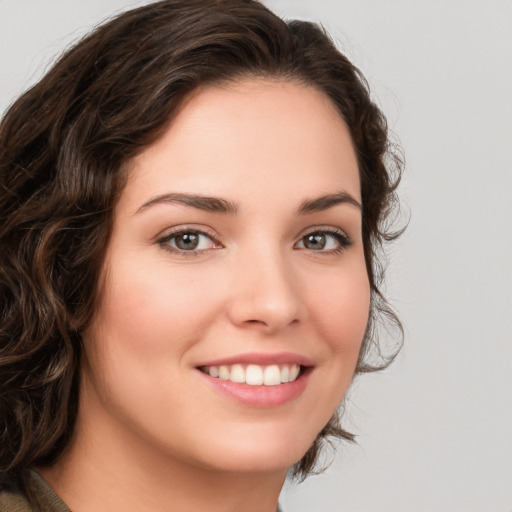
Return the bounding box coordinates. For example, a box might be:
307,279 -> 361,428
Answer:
0,0 -> 400,512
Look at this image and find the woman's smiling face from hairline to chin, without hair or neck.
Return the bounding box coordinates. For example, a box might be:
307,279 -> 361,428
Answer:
78,80 -> 370,472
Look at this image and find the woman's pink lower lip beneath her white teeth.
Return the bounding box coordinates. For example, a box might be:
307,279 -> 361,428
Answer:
200,369 -> 311,408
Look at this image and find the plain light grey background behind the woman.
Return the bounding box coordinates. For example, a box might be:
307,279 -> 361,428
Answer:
0,0 -> 512,512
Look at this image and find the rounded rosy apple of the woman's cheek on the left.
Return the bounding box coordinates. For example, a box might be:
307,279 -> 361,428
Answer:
97,262 -> 224,359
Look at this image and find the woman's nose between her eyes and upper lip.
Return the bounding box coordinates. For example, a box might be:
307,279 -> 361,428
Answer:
228,247 -> 306,334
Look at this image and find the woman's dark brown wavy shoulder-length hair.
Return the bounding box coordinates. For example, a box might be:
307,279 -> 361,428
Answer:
0,0 -> 402,488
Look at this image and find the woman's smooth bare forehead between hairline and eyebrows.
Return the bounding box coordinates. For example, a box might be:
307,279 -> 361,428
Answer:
122,79 -> 360,210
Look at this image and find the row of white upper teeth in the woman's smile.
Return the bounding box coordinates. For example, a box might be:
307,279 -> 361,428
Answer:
201,364 -> 300,386
